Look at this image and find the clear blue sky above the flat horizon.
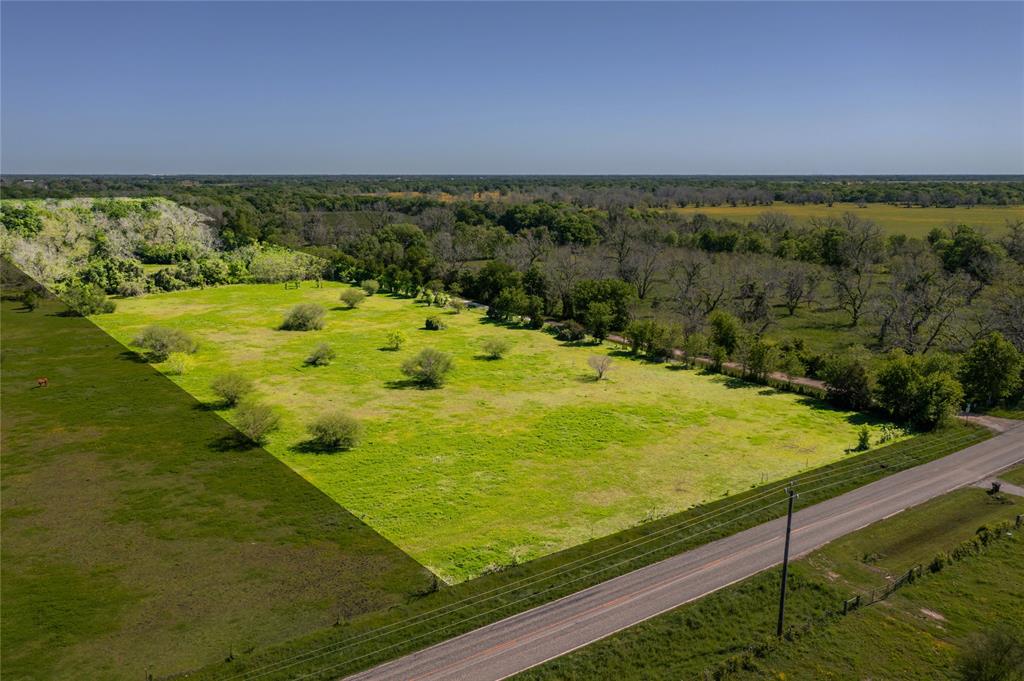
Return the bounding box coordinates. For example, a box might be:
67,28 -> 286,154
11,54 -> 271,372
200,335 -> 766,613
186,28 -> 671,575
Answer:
0,1 -> 1024,174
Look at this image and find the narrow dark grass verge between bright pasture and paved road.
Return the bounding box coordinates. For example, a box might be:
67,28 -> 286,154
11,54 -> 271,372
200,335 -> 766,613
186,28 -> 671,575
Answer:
189,424 -> 991,680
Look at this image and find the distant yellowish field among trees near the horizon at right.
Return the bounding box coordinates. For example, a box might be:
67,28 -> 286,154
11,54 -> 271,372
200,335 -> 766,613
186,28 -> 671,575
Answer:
674,202 -> 1024,239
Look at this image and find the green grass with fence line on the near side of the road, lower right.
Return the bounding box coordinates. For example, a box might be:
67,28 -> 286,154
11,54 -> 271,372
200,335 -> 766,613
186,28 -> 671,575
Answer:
514,488 -> 1024,681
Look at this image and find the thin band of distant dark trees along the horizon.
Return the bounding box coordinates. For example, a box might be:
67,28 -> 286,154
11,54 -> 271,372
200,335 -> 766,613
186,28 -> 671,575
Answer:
0,175 -> 1024,210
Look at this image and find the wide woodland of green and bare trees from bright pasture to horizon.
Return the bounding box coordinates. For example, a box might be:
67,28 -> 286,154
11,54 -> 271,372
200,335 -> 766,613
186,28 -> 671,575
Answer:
3,177 -> 1024,425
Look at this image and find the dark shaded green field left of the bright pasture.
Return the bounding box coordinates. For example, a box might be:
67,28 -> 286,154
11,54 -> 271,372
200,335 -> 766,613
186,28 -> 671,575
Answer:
0,266 -> 431,681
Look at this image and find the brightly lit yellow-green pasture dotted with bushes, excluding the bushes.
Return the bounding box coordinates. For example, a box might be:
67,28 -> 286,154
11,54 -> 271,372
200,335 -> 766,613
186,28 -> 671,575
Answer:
95,284 -> 901,582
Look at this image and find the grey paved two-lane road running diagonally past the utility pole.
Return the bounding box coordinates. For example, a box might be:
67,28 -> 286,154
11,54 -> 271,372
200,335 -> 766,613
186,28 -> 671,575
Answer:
349,427 -> 1024,681
